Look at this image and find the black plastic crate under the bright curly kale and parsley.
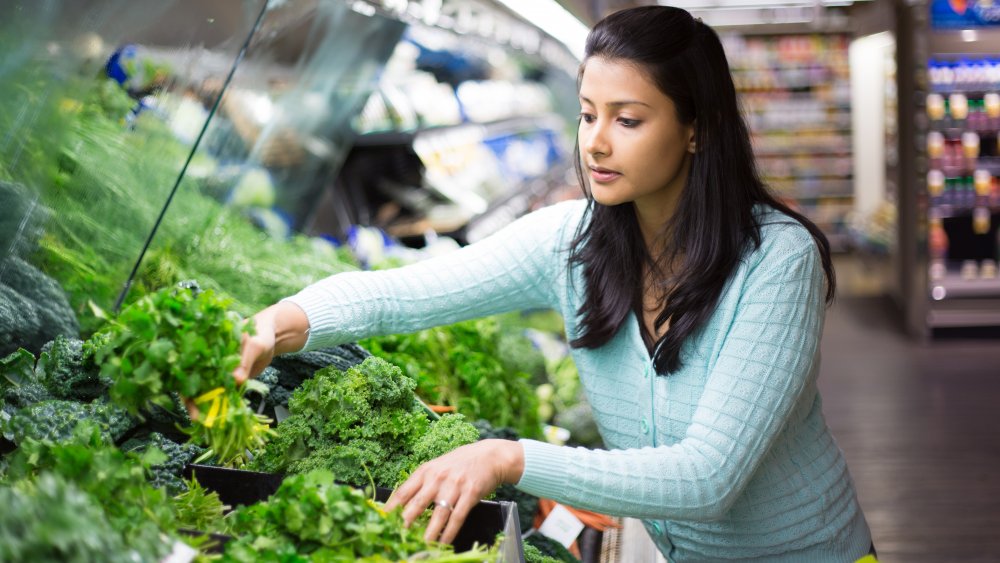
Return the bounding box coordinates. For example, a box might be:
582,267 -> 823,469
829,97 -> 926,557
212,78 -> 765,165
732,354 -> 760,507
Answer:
184,464 -> 524,563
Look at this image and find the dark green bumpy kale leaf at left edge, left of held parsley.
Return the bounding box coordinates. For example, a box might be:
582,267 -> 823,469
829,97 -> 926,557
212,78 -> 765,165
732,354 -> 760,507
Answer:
3,399 -> 138,444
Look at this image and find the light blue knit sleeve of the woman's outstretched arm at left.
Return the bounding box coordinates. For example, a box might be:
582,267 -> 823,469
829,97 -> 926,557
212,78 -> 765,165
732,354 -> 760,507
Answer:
285,202 -> 581,350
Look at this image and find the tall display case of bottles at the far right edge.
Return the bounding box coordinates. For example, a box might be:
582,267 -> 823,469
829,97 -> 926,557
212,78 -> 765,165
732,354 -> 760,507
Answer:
899,0 -> 1000,337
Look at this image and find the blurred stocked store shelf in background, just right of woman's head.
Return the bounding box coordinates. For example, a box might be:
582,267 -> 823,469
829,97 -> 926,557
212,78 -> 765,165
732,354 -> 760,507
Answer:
724,34 -> 854,249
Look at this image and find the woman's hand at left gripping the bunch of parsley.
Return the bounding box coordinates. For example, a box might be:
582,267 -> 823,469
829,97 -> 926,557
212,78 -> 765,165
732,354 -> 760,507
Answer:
233,301 -> 309,383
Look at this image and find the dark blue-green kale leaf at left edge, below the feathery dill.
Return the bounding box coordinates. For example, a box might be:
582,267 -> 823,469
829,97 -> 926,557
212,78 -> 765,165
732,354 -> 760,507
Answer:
0,256 -> 80,353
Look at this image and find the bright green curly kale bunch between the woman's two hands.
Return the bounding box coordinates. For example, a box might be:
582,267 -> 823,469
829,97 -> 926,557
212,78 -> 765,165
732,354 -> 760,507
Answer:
251,357 -> 479,487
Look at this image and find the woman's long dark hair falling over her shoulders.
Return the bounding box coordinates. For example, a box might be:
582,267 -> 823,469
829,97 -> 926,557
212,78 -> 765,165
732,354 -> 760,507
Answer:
570,6 -> 836,375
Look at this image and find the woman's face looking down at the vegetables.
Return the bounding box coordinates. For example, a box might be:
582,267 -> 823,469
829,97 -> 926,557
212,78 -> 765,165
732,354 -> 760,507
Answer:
579,58 -> 695,216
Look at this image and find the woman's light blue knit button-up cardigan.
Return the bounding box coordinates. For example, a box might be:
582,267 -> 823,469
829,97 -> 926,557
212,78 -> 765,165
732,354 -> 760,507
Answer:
288,201 -> 871,562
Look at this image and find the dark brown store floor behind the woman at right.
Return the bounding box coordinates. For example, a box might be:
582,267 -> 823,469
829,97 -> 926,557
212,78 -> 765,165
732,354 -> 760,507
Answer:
820,258 -> 1000,563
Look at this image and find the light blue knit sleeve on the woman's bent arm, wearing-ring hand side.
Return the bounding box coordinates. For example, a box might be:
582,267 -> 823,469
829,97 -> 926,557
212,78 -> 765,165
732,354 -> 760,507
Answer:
517,232 -> 825,521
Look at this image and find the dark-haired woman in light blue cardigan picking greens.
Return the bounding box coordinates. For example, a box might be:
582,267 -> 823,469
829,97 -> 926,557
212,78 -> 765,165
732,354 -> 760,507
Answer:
237,7 -> 872,562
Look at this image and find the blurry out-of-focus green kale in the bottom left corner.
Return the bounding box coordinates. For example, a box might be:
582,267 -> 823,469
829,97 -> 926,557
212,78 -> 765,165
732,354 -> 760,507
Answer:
0,474 -> 134,563
